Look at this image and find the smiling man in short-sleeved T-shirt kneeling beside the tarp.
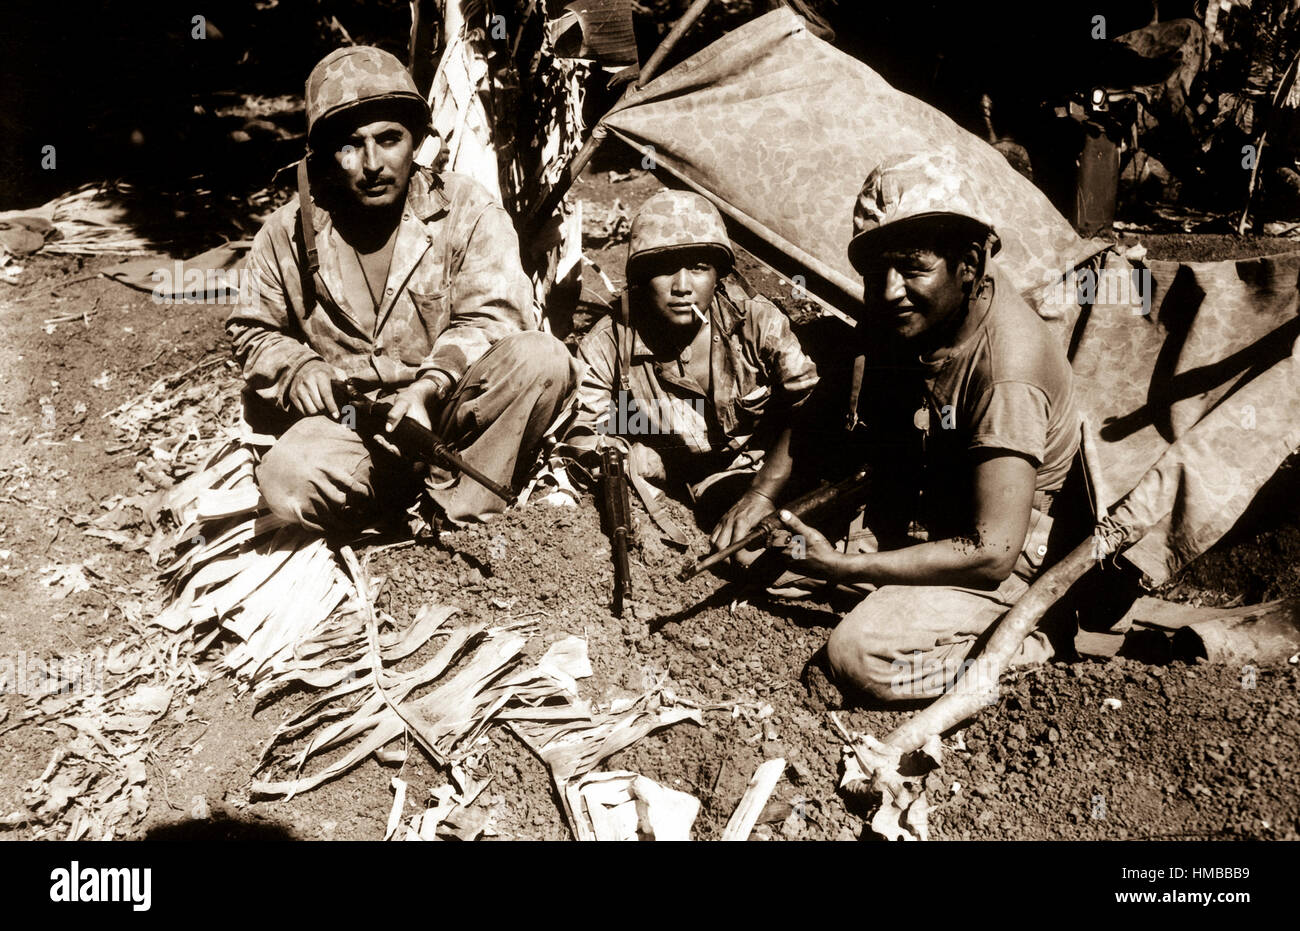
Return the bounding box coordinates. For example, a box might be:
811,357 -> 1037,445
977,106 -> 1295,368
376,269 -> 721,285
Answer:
781,155 -> 1082,701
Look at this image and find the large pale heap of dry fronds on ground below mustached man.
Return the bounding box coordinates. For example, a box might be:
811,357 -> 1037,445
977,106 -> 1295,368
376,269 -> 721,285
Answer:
129,392 -> 701,836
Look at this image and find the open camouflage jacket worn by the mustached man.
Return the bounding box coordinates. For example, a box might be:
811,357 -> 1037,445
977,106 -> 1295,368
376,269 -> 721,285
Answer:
226,170 -> 537,408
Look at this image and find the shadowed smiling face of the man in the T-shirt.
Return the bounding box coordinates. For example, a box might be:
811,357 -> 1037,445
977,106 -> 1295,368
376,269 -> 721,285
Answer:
862,247 -> 974,339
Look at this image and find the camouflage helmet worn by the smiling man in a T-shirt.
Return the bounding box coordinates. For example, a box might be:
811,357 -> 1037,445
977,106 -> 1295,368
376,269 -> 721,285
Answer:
849,152 -> 1001,272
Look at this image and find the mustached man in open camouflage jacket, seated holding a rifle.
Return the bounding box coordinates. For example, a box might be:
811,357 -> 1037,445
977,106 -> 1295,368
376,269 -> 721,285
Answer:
226,47 -> 577,531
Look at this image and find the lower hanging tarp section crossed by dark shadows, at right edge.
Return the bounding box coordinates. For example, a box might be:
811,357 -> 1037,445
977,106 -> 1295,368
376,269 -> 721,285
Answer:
1071,247 -> 1300,585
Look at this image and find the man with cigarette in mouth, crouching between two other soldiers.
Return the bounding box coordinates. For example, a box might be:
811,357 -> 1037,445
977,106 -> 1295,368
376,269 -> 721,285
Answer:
567,191 -> 818,547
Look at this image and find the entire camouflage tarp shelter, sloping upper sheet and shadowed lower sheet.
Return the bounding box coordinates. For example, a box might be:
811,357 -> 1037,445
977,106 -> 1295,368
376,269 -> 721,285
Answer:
592,9 -> 1300,584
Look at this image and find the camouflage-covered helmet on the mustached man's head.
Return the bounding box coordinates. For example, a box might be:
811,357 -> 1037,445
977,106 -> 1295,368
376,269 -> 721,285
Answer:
307,46 -> 429,144
